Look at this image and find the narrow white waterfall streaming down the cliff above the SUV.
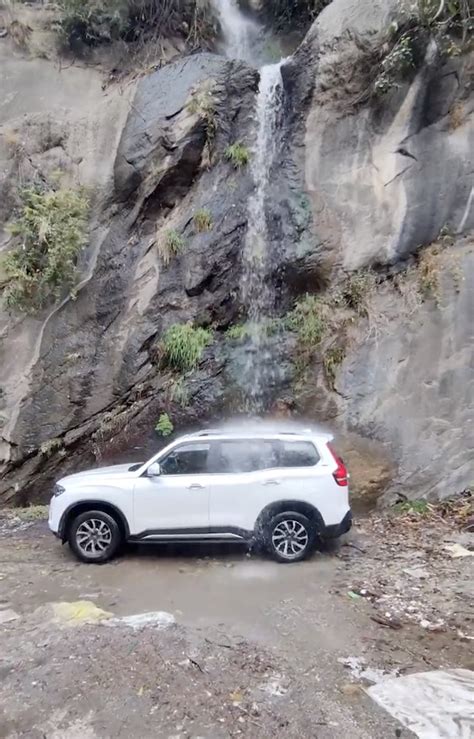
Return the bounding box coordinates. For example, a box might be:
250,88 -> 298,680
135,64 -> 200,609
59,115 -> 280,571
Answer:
213,0 -> 283,413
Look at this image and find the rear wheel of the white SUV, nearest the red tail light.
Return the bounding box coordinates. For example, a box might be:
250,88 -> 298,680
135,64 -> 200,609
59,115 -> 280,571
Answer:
265,511 -> 317,564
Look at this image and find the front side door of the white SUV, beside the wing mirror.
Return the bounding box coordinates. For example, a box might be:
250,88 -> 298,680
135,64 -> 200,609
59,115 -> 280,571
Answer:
134,441 -> 210,536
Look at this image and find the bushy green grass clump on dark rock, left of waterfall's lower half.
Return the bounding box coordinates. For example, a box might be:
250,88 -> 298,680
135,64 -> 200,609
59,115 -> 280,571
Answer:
160,323 -> 212,372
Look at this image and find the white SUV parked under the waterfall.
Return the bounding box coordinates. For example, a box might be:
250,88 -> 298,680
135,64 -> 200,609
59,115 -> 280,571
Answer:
49,429 -> 352,563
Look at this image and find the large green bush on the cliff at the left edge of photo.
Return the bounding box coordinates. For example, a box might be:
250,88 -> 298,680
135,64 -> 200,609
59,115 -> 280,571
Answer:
3,187 -> 89,311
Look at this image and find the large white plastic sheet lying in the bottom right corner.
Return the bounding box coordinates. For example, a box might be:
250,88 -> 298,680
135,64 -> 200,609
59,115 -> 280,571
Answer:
367,669 -> 474,739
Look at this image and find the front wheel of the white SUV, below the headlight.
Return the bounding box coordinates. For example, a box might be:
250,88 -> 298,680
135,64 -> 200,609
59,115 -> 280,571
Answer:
68,511 -> 123,564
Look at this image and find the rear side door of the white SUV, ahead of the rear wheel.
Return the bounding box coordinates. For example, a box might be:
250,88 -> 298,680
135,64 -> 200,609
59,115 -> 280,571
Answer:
209,439 -> 281,533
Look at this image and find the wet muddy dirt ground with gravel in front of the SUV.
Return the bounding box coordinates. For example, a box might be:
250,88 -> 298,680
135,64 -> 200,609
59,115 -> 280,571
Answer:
0,506 -> 474,739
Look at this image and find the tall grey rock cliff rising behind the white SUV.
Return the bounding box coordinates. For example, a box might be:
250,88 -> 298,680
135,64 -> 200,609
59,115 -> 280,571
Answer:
0,0 -> 474,503
